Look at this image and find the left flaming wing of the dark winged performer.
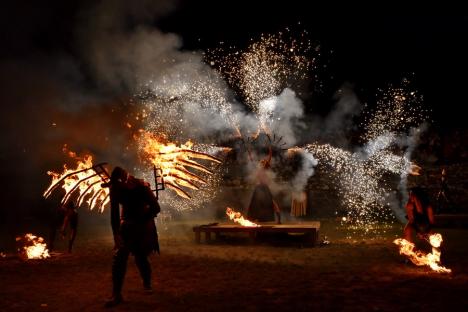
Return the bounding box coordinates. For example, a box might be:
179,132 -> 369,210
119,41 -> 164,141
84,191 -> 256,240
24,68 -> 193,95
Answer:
43,152 -> 109,212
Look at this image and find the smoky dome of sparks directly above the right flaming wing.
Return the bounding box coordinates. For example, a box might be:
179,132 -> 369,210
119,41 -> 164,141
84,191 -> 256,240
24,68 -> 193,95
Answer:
137,65 -> 239,140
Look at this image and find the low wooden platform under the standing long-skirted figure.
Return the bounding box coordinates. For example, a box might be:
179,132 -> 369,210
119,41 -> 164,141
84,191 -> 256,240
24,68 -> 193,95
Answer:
193,221 -> 320,246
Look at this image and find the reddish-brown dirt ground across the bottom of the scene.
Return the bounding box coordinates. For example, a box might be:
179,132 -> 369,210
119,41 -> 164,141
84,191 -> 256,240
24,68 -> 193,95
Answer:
0,220 -> 468,311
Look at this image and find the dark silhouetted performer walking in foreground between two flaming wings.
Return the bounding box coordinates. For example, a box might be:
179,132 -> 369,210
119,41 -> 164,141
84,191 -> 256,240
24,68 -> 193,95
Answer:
103,167 -> 160,306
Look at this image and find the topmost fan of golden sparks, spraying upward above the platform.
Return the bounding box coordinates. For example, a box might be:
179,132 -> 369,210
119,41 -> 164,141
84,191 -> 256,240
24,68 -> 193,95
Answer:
206,29 -> 315,113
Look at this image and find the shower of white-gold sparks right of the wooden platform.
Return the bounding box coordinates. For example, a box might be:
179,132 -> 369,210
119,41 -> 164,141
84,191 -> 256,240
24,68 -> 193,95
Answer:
304,83 -> 427,228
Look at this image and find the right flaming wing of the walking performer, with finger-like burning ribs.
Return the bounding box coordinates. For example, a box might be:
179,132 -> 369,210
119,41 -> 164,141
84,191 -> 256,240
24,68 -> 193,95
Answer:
139,130 -> 221,199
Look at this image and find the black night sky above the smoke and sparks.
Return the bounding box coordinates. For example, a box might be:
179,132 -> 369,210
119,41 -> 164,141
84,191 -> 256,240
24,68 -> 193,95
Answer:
0,1 -> 468,128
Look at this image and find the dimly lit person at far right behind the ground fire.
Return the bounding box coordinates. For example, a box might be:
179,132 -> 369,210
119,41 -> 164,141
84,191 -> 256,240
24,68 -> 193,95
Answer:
404,187 -> 434,242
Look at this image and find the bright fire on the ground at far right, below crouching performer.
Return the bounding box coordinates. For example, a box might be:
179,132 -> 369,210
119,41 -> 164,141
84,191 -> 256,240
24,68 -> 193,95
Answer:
393,233 -> 452,273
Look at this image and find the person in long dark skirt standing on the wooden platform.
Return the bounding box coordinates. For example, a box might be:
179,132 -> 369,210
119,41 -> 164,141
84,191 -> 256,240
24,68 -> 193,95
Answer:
246,148 -> 281,224
